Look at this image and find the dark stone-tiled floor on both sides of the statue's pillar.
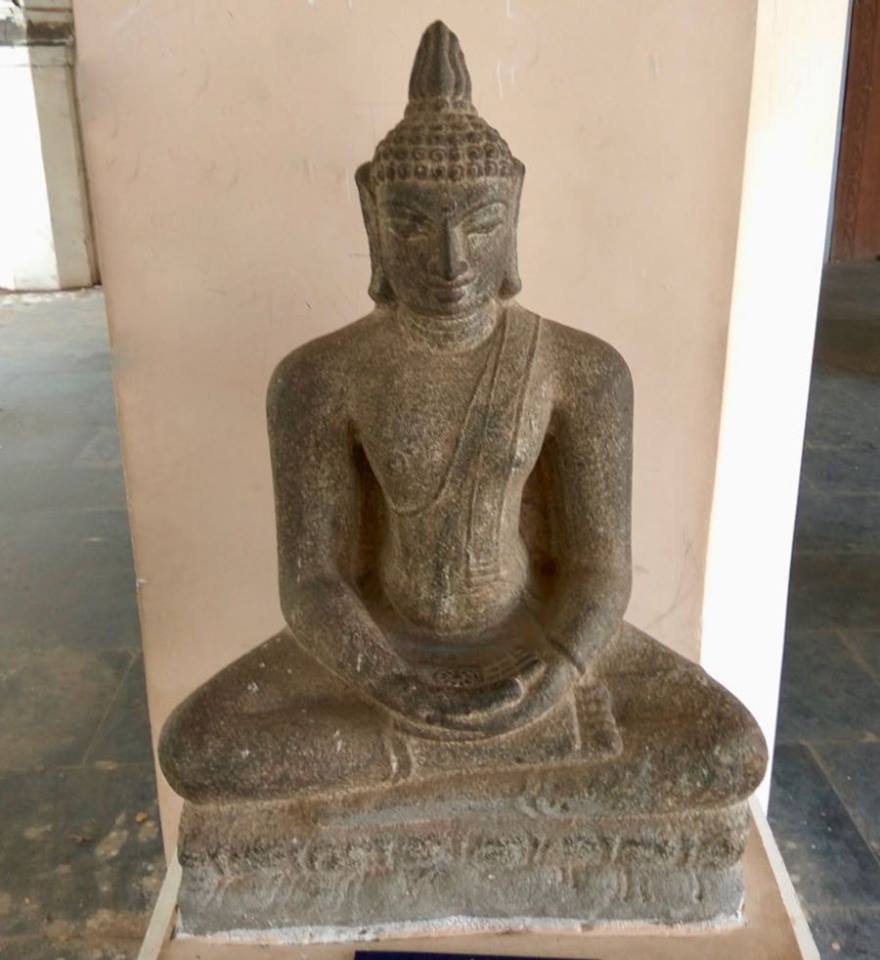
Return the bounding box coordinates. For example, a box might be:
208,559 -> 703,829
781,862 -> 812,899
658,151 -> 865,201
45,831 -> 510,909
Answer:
0,264 -> 880,960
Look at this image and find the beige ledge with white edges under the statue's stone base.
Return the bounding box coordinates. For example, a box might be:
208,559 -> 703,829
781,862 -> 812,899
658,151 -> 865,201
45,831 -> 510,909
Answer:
138,805 -> 819,960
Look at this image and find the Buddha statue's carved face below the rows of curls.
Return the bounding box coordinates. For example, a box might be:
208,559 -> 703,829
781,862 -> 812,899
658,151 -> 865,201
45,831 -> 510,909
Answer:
376,179 -> 518,317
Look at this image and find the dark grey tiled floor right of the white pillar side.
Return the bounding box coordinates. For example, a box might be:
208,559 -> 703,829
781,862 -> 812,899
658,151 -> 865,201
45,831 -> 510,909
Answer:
770,263 -> 880,960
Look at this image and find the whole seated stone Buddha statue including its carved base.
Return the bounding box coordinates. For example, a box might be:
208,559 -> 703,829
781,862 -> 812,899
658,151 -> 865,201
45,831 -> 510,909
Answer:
159,22 -> 766,940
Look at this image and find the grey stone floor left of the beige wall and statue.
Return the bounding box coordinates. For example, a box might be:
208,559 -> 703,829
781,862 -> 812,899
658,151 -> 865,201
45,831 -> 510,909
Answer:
0,292 -> 163,960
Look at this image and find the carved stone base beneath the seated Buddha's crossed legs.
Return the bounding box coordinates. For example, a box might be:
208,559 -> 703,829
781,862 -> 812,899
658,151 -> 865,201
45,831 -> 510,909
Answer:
179,804 -> 749,943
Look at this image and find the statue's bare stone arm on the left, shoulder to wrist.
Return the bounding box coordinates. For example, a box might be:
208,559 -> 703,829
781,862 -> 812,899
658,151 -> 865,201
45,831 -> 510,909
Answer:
267,355 -> 408,699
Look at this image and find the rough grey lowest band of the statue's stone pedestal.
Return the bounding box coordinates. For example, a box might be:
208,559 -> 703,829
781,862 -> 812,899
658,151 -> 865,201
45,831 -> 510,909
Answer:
179,838 -> 743,942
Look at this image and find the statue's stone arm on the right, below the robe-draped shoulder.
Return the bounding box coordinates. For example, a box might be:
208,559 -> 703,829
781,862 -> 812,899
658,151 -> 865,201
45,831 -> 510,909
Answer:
547,348 -> 633,674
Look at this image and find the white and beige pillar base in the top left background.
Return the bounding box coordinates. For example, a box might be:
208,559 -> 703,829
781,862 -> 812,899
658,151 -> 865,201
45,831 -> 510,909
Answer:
0,0 -> 98,290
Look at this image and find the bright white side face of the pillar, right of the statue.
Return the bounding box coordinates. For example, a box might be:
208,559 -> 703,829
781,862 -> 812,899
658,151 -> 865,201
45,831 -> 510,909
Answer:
701,0 -> 849,808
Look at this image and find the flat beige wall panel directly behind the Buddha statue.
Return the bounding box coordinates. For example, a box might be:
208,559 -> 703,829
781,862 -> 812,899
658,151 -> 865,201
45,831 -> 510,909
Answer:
75,0 -> 755,840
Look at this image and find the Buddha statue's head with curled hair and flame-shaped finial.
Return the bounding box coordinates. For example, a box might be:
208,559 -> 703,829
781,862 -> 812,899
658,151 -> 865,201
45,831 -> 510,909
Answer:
357,21 -> 525,317
